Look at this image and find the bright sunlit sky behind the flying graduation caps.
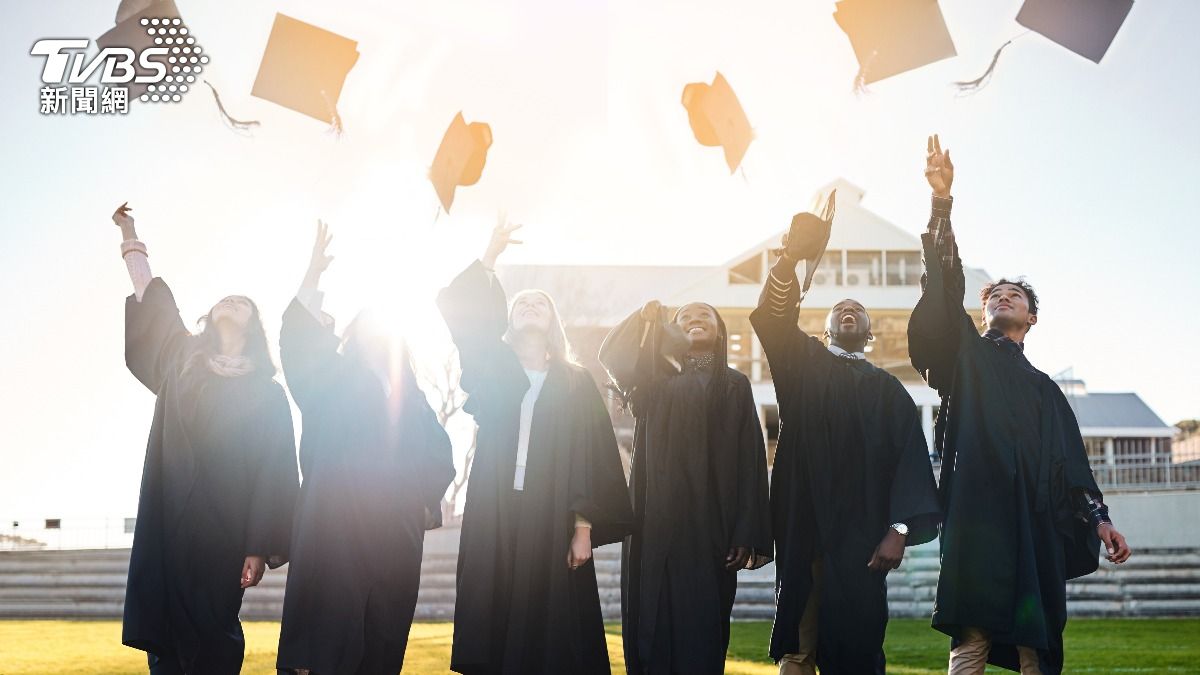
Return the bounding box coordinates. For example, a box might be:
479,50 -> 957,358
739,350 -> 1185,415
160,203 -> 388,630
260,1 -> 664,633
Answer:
0,0 -> 1200,518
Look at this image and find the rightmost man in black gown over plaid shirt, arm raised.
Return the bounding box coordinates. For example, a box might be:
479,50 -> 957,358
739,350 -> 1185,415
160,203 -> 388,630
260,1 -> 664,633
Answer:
908,137 -> 1129,675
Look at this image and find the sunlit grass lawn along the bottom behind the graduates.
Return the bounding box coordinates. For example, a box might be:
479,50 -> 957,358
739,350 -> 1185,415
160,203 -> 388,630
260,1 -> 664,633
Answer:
0,619 -> 1200,675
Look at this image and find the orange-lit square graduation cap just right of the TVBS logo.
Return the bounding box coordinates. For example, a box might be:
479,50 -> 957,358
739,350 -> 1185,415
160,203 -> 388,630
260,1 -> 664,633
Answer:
251,13 -> 359,131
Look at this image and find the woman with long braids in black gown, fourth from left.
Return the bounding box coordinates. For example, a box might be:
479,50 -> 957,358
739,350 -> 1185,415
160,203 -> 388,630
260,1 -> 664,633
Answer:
600,301 -> 772,675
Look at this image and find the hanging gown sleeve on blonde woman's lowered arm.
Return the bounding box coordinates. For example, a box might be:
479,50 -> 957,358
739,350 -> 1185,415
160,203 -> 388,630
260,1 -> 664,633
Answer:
570,374 -> 634,546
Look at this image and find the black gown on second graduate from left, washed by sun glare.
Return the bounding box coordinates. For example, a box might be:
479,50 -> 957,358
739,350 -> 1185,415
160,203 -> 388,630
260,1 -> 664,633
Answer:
277,300 -> 454,675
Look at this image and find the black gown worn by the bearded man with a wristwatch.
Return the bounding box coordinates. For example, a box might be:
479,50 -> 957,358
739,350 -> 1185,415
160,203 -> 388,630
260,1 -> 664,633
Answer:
750,269 -> 940,675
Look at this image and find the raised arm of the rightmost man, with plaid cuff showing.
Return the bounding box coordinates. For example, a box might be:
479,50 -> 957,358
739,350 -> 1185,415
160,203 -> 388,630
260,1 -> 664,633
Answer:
908,136 -> 972,393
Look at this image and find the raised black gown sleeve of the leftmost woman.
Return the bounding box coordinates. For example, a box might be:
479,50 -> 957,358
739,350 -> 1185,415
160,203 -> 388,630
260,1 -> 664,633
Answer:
125,277 -> 196,394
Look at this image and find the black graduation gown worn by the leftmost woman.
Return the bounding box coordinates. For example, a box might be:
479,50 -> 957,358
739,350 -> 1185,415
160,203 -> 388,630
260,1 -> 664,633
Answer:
121,277 -> 299,675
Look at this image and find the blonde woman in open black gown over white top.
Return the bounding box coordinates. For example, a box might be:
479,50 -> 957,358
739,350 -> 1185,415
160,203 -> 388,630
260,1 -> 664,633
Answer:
438,225 -> 632,675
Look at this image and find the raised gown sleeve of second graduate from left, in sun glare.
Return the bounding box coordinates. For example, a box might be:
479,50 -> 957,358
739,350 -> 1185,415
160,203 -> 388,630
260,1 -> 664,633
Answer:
280,299 -> 341,411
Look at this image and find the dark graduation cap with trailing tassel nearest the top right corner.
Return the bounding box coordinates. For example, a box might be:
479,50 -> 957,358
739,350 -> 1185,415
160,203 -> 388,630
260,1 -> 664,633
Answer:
955,0 -> 1133,90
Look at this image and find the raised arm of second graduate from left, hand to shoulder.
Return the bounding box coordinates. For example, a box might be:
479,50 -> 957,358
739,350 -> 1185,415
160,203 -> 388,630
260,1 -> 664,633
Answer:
280,221 -> 340,408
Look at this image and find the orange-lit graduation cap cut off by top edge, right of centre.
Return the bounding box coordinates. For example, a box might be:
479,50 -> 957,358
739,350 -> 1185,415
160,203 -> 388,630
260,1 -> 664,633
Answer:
833,0 -> 956,89
